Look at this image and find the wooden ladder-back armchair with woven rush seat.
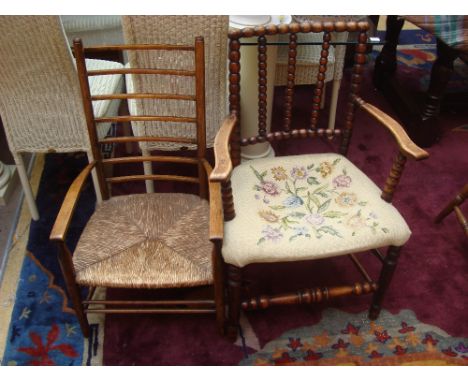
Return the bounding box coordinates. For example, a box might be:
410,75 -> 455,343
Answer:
50,37 -> 224,336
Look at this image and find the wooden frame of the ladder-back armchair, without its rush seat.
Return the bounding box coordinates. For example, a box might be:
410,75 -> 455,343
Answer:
50,37 -> 224,337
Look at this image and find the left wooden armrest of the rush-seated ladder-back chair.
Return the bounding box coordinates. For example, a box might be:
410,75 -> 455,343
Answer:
49,161 -> 96,242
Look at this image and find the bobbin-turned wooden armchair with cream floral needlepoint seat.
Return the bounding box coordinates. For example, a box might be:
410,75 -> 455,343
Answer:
210,22 -> 428,338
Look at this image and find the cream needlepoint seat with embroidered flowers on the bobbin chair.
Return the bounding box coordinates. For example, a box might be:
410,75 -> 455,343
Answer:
222,153 -> 411,267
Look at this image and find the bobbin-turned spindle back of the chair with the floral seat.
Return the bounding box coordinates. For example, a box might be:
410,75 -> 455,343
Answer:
229,21 -> 368,170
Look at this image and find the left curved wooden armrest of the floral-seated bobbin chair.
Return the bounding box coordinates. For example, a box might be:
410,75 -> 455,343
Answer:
209,114 -> 237,182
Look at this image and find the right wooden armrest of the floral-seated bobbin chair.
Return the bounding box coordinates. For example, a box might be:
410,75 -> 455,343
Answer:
354,96 -> 429,160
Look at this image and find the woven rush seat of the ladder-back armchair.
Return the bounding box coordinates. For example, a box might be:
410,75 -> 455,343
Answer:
73,194 -> 212,288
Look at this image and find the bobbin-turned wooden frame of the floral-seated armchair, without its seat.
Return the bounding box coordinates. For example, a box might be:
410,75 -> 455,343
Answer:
210,21 -> 428,339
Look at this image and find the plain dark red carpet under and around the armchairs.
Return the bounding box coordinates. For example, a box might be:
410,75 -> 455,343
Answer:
103,59 -> 468,365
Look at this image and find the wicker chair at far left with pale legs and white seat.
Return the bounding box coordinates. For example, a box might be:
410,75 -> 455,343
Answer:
0,16 -> 124,220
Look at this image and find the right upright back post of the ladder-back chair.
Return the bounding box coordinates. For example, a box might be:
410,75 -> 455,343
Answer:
195,36 -> 208,199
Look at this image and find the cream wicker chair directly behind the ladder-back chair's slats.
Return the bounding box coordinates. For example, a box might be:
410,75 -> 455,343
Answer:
122,16 -> 229,192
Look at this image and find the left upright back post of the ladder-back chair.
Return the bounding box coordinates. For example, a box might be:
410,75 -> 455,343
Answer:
73,38 -> 109,200
